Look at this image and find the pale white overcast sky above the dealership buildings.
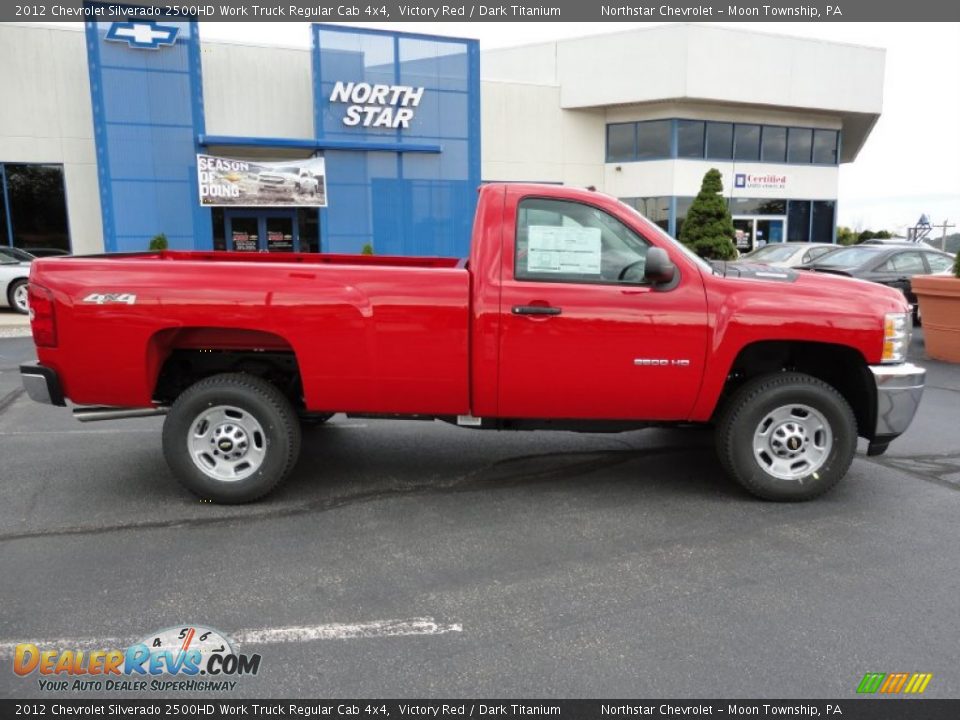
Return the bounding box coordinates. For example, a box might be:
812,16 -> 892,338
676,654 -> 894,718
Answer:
26,22 -> 960,234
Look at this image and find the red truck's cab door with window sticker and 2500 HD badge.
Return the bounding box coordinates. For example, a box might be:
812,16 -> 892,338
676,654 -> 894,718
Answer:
498,191 -> 707,420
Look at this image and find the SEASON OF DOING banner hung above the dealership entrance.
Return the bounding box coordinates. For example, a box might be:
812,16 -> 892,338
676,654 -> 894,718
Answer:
197,155 -> 327,207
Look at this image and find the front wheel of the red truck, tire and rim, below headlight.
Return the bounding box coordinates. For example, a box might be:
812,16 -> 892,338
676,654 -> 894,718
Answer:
716,373 -> 857,502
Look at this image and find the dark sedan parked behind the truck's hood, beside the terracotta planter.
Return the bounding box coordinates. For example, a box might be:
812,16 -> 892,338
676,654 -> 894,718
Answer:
800,243 -> 954,320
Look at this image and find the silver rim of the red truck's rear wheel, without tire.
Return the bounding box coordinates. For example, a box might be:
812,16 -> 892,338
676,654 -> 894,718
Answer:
187,405 -> 267,482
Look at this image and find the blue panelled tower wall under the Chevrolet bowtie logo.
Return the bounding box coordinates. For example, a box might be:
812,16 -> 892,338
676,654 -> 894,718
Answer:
86,8 -> 213,252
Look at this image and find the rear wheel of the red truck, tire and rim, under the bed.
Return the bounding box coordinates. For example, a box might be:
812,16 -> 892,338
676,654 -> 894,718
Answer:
163,373 -> 300,504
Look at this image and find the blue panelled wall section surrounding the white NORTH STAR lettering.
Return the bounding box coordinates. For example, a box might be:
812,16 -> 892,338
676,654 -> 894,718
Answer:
313,25 -> 480,256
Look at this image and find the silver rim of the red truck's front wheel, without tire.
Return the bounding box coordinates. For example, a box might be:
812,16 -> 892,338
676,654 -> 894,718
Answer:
753,403 -> 833,480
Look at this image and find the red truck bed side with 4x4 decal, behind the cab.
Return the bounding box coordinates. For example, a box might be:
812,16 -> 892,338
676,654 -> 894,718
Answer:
31,251 -> 470,415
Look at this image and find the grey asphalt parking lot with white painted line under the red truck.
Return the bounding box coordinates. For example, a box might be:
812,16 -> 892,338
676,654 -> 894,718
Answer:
0,320 -> 960,698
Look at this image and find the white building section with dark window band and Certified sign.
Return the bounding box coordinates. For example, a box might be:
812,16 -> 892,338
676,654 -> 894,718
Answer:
482,25 -> 884,249
